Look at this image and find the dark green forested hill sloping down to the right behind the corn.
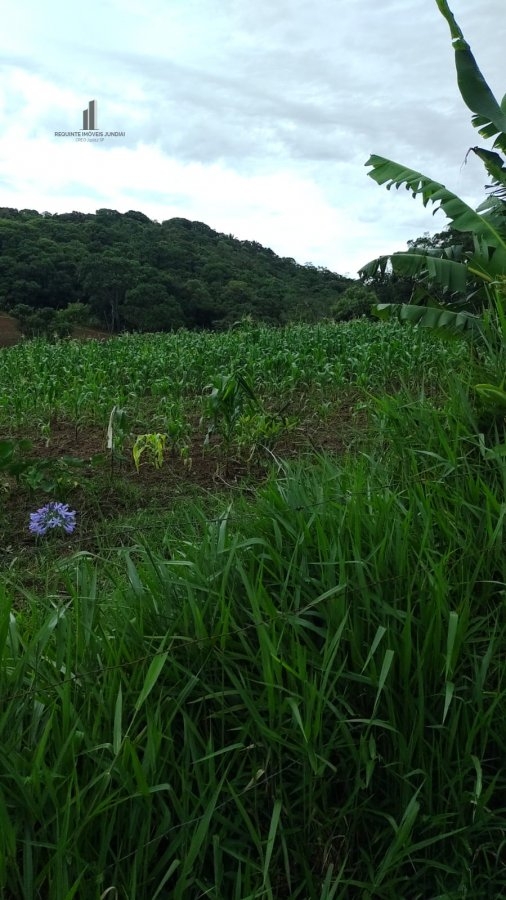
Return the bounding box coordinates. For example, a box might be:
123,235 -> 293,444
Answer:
0,208 -> 355,331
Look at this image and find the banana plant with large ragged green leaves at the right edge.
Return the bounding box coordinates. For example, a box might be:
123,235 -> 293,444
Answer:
360,0 -> 506,338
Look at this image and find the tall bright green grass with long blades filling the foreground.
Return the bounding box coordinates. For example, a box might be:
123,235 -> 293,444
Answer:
0,384 -> 506,900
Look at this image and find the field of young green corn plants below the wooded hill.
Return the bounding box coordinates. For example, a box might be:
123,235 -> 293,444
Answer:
0,319 -> 468,434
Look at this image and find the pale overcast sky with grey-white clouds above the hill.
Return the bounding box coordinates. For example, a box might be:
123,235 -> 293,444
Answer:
0,0 -> 506,276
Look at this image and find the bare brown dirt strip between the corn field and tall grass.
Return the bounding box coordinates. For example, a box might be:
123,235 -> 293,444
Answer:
0,398 -> 365,553
